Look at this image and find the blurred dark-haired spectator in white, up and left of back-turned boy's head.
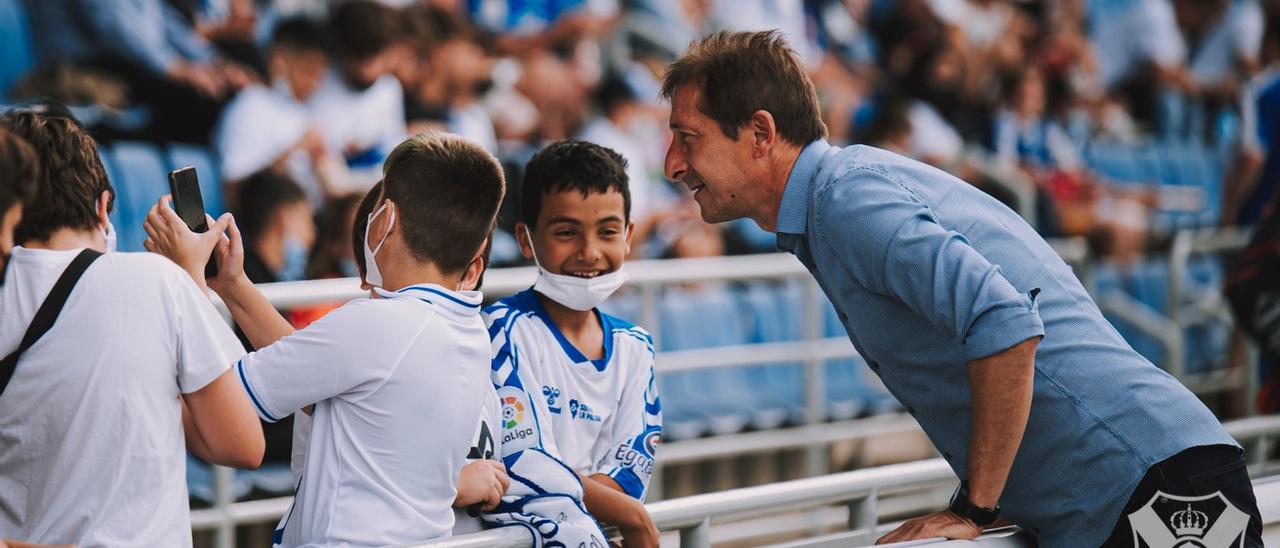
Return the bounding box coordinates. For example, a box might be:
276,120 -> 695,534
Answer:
308,0 -> 408,193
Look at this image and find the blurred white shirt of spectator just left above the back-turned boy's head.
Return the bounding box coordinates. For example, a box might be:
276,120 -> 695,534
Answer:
307,69 -> 404,191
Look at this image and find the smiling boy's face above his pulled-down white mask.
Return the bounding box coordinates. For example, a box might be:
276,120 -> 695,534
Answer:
516,189 -> 634,278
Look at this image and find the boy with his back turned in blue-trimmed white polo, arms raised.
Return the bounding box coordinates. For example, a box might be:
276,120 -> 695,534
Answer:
147,134 -> 503,545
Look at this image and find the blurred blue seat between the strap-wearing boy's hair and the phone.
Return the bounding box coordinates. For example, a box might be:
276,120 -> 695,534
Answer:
102,141 -> 169,251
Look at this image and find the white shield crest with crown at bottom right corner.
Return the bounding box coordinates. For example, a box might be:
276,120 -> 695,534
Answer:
1129,490 -> 1249,548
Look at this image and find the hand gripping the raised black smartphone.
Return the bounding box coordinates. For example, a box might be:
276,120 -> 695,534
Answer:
142,195 -> 232,288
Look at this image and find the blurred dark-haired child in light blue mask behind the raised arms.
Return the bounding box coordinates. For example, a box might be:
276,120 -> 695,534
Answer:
237,170 -> 316,283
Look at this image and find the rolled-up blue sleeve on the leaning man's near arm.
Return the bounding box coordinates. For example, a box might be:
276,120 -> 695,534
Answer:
815,168 -> 1044,361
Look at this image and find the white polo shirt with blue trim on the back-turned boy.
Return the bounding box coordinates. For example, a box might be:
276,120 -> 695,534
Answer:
236,284 -> 489,545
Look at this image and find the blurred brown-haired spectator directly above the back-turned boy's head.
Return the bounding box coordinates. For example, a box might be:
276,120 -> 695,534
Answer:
398,4 -> 498,154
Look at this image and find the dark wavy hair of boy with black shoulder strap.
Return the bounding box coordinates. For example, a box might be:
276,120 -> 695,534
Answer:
0,111 -> 115,243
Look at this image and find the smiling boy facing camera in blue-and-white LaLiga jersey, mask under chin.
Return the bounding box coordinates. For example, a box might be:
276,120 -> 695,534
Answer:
485,141 -> 662,547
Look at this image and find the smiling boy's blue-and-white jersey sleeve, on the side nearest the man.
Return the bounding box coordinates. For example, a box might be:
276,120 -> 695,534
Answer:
591,335 -> 662,501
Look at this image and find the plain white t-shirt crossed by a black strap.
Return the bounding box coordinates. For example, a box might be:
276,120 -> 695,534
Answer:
0,247 -> 244,547
